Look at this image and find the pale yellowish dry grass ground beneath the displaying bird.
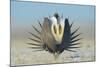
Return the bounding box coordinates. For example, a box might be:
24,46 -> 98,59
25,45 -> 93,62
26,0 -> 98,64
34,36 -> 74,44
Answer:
11,40 -> 95,65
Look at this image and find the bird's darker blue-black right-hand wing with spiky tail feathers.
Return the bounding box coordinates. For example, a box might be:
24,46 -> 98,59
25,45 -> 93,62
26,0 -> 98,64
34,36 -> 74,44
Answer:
58,18 -> 80,53
